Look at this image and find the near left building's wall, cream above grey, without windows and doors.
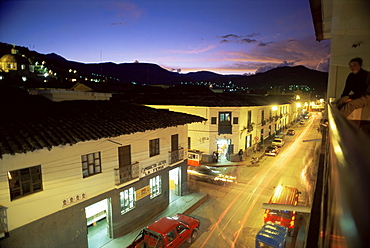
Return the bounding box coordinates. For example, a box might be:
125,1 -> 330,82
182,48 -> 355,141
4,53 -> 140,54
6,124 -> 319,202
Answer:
0,125 -> 187,247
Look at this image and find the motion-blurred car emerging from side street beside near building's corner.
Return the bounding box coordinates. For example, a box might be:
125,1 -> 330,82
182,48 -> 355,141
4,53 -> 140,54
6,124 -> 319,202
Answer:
188,166 -> 236,185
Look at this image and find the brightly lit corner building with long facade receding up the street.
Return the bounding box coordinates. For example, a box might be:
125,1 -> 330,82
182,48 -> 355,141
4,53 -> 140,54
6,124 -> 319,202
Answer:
147,103 -> 299,162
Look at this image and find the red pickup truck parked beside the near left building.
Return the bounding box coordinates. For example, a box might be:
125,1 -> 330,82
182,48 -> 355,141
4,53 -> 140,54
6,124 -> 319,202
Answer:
126,214 -> 200,248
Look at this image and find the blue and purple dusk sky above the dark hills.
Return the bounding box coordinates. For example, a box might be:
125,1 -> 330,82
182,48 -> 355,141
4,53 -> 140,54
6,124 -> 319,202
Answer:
0,0 -> 330,74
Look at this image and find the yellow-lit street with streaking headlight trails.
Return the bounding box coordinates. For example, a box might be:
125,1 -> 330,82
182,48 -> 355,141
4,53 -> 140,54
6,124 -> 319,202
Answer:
183,118 -> 321,248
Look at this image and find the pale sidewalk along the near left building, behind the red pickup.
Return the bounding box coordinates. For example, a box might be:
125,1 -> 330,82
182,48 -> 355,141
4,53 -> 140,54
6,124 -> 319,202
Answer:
102,192 -> 208,248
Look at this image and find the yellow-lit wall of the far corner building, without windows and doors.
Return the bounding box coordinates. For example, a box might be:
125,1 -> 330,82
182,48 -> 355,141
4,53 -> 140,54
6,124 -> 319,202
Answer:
148,104 -> 293,162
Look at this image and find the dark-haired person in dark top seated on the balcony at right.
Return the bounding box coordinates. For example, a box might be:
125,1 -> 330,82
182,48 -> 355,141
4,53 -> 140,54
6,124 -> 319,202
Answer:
337,58 -> 370,117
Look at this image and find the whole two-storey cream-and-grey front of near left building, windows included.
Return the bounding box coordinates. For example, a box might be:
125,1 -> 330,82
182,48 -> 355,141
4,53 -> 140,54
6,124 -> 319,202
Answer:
0,95 -> 202,247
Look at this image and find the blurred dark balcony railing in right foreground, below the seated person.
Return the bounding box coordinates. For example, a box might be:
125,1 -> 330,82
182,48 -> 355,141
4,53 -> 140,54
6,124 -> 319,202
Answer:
306,105 -> 370,248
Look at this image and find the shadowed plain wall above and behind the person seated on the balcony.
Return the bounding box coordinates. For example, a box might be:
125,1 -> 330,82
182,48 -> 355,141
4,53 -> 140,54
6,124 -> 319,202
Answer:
325,0 -> 370,99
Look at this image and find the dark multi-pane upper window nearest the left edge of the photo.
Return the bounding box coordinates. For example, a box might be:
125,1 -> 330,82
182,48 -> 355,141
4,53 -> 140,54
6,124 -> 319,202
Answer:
8,165 -> 42,201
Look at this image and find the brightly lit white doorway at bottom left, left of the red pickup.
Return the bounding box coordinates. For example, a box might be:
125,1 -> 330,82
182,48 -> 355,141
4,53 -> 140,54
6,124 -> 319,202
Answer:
85,198 -> 112,248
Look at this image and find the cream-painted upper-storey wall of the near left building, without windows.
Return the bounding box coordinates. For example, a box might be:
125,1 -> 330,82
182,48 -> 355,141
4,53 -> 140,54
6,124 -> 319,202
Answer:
0,125 -> 188,231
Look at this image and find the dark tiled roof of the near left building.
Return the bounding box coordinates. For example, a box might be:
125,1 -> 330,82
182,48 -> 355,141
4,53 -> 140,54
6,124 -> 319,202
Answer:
0,88 -> 206,158
